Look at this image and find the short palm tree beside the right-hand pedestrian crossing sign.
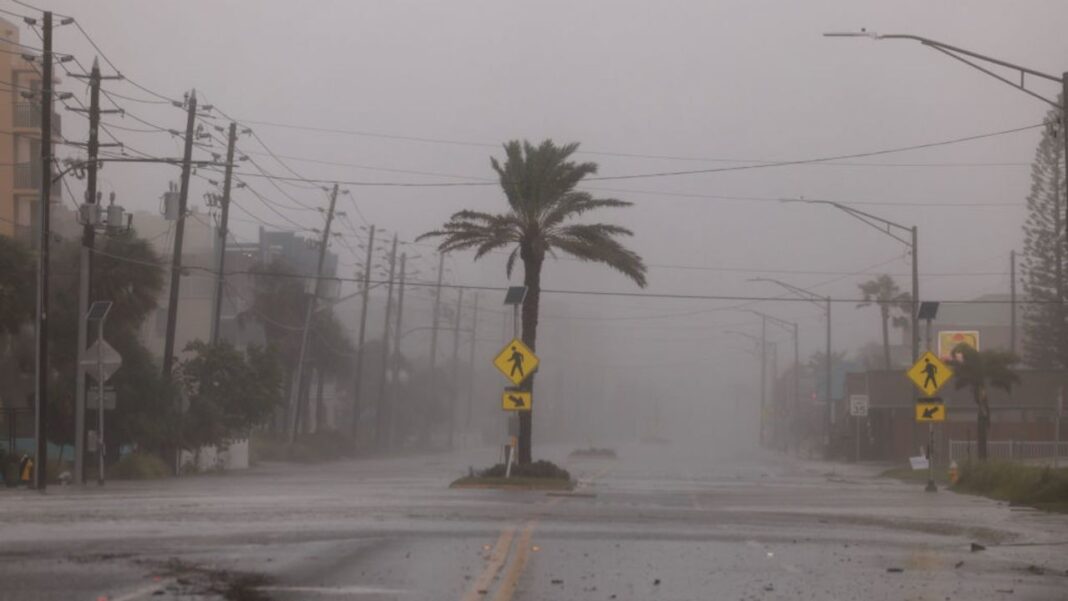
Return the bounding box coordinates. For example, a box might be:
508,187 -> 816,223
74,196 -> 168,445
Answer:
949,343 -> 1020,461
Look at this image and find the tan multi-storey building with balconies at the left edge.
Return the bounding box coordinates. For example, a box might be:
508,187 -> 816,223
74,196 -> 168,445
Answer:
0,18 -> 63,243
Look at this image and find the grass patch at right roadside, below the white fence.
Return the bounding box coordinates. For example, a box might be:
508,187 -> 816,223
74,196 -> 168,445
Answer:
954,461 -> 1068,511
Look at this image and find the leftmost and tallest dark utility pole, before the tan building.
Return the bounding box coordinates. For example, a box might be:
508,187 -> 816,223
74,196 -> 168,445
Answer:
33,11 -> 53,492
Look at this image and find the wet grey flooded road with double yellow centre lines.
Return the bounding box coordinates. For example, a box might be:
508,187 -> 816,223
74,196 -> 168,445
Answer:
0,445 -> 1068,601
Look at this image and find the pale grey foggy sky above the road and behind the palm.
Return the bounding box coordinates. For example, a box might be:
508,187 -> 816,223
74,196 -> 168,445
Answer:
23,0 -> 1068,454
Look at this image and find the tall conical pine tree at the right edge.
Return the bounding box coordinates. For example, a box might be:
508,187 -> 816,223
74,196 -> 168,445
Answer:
1022,97 -> 1068,369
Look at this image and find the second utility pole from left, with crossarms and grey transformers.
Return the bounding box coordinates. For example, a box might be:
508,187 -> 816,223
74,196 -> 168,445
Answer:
70,58 -> 121,485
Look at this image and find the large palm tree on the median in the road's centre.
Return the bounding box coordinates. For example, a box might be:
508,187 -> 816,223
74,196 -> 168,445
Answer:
420,140 -> 646,463
